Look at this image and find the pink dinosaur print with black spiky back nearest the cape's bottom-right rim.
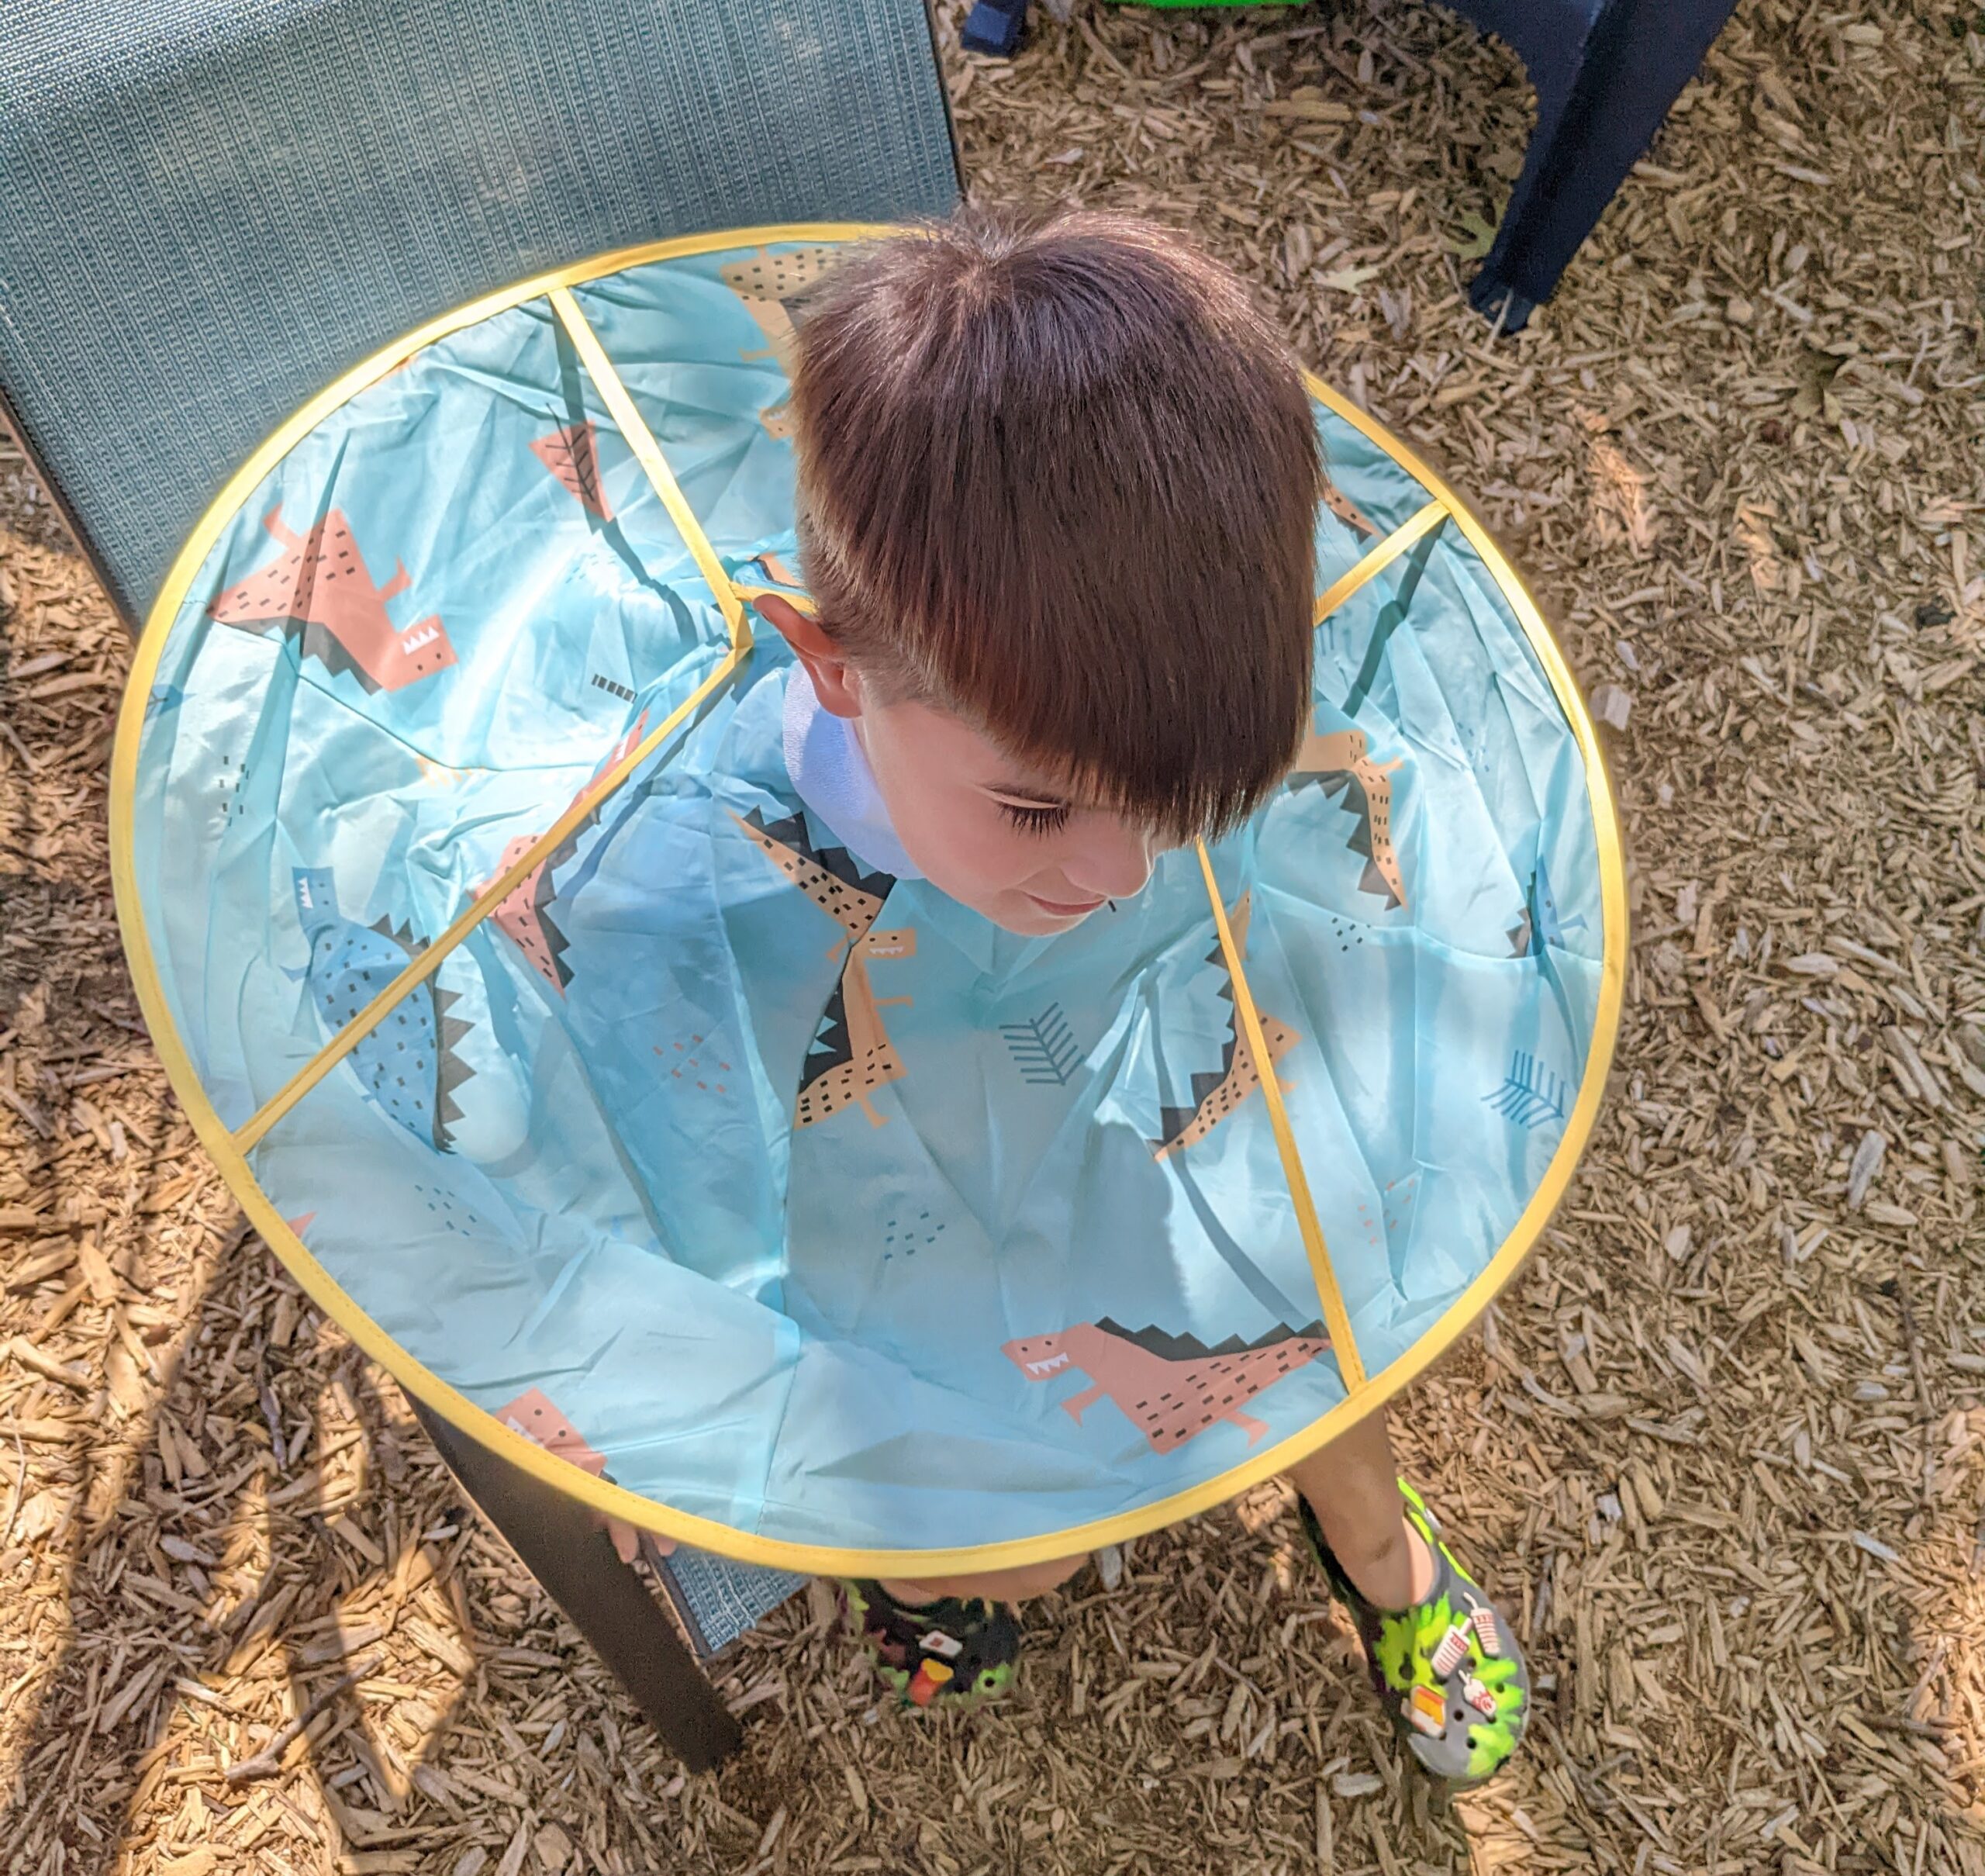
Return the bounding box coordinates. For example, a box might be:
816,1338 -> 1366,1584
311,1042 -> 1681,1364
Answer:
1003,1316 -> 1330,1453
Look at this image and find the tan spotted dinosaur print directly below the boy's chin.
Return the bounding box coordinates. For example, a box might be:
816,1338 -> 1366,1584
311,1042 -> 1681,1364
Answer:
730,808 -> 917,1128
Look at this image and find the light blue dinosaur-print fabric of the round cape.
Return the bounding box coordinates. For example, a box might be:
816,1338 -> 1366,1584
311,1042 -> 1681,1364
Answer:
123,230 -> 1624,1560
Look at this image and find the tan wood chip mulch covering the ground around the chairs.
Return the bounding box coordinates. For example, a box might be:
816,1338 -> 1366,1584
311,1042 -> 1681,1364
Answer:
0,0 -> 1985,1876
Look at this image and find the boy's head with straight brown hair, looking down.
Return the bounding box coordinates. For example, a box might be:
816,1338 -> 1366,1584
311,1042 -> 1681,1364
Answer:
765,209 -> 1320,933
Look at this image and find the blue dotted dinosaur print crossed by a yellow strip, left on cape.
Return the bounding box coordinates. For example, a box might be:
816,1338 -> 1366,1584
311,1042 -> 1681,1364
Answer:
294,865 -> 471,1152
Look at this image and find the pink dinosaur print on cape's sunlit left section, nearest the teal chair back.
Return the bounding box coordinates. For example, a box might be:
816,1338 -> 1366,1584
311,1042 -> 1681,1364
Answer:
206,504 -> 454,691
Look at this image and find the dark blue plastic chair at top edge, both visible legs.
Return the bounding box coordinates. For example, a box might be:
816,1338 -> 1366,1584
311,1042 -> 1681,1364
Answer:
958,0 -> 1733,331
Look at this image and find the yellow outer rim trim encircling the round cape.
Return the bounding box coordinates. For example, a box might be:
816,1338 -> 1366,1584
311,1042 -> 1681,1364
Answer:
111,234 -> 1628,1578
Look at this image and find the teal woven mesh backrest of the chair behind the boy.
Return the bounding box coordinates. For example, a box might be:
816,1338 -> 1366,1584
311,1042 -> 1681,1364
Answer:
0,0 -> 957,616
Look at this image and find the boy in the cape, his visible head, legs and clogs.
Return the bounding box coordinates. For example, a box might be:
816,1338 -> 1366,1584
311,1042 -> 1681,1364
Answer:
738,210 -> 1528,1783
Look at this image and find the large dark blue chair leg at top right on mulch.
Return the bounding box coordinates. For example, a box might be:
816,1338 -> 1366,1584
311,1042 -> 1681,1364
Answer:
1459,0 -> 1733,331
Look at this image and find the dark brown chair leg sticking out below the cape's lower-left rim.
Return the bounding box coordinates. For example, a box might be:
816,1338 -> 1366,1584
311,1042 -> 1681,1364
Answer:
413,1401 -> 742,1771
